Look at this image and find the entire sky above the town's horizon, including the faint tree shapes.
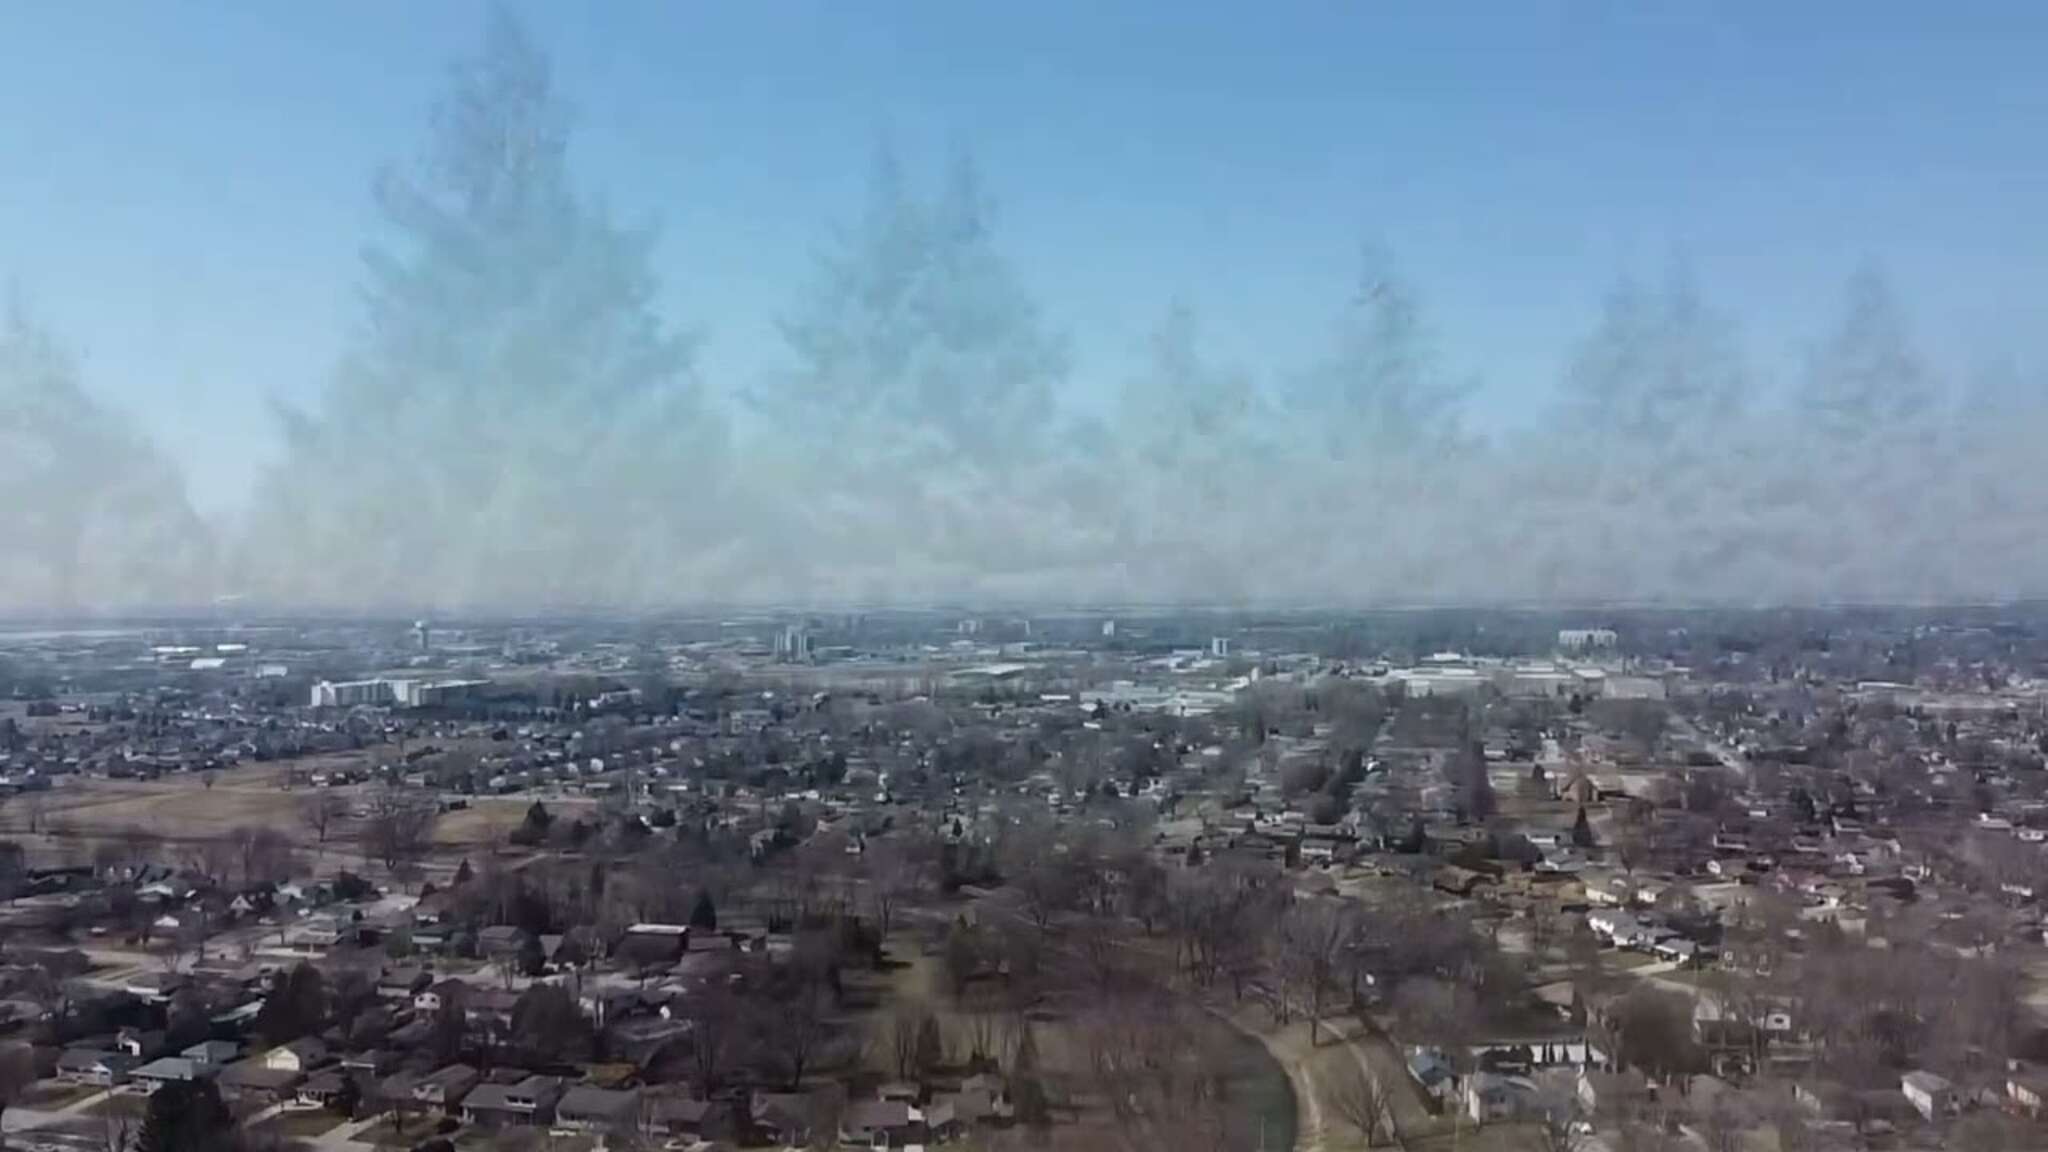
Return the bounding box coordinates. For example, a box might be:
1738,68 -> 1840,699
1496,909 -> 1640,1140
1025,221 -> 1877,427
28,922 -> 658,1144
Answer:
0,2 -> 2048,617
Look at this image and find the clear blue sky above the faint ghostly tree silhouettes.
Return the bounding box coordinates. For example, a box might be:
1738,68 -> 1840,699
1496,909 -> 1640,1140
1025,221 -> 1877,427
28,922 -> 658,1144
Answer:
0,0 -> 2048,512
